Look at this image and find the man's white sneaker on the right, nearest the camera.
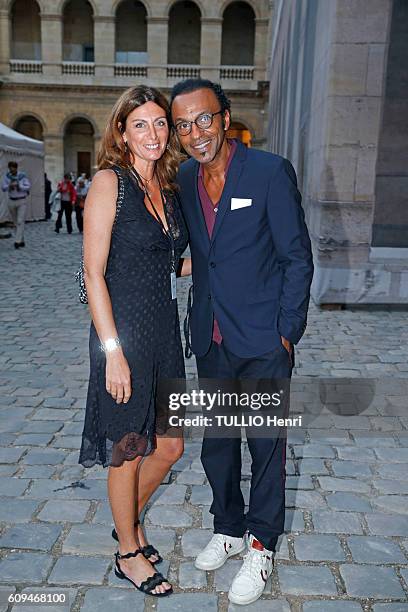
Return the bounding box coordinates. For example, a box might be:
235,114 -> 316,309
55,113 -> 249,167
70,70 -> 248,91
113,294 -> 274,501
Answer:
228,535 -> 274,605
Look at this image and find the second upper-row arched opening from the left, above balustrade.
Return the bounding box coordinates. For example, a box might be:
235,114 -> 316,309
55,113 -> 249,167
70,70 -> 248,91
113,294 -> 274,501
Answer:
62,0 -> 94,62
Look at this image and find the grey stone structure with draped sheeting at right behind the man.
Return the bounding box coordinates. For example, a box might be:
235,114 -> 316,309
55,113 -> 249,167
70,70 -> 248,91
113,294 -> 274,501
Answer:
268,0 -> 408,304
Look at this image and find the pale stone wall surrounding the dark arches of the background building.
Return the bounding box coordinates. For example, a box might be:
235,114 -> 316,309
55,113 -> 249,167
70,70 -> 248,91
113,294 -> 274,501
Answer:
0,0 -> 270,181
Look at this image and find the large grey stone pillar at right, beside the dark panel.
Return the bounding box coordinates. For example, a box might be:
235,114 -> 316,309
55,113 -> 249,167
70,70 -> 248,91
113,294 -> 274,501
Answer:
306,0 -> 396,304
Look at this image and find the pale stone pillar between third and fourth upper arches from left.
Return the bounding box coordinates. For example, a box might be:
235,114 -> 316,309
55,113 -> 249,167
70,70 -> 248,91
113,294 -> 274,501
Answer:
147,17 -> 169,84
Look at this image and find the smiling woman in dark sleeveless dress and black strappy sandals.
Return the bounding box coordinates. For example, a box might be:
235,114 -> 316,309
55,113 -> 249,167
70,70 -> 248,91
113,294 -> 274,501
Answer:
79,86 -> 190,597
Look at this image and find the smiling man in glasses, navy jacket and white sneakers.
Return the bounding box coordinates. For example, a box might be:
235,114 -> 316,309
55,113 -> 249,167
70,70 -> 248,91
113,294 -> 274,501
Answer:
171,79 -> 313,604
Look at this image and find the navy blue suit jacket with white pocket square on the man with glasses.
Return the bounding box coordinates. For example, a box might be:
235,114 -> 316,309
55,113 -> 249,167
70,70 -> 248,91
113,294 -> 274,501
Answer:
178,142 -> 313,357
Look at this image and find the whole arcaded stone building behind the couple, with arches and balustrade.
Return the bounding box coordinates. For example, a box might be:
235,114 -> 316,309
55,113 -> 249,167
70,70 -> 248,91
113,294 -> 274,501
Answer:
0,0 -> 271,181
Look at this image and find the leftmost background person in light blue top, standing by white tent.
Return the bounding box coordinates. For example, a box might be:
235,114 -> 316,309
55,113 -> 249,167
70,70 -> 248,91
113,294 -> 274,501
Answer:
1,161 -> 31,249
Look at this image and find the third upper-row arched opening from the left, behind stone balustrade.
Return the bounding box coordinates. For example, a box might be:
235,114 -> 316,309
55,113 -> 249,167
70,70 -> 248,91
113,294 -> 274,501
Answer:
115,0 -> 147,64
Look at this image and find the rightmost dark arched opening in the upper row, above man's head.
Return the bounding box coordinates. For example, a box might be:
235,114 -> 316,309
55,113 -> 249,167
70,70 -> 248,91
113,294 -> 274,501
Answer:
221,2 -> 255,66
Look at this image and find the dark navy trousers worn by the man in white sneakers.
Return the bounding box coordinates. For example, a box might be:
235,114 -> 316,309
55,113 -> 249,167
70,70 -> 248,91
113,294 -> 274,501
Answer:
197,342 -> 293,550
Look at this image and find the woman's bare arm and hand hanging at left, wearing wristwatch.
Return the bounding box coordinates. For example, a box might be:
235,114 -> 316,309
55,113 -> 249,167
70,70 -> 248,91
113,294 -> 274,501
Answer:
84,170 -> 131,404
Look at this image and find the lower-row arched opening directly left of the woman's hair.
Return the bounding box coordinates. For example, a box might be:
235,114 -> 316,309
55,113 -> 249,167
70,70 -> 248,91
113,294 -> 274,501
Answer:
64,117 -> 94,176
